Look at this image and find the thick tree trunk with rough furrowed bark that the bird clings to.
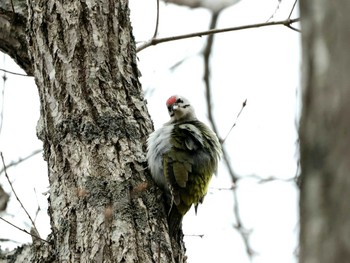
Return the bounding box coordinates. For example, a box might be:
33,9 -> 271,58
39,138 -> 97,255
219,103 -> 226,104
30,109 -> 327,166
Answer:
0,0 -> 185,262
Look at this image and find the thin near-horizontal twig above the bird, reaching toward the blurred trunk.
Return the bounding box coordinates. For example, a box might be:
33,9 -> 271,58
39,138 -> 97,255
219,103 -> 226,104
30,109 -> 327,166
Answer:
136,18 -> 300,52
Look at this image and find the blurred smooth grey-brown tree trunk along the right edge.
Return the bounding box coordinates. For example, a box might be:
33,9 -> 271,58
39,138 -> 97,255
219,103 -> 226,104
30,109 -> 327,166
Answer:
300,0 -> 350,263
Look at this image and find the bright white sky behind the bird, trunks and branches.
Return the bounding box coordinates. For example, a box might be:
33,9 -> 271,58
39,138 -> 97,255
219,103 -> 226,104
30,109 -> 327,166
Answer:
0,0 -> 300,263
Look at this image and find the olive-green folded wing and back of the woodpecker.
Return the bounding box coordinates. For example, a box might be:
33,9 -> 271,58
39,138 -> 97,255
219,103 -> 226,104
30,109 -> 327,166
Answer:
163,121 -> 218,215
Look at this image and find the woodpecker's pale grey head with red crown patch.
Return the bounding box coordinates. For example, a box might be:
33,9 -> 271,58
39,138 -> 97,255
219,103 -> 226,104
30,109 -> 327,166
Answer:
166,95 -> 197,122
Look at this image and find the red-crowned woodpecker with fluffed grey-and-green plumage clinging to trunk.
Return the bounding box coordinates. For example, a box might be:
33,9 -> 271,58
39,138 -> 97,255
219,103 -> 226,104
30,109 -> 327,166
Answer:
147,95 -> 221,235
